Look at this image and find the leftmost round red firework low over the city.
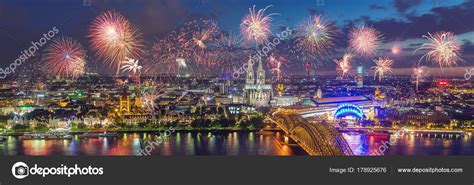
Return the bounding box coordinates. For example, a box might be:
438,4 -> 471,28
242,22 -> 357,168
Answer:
44,37 -> 86,79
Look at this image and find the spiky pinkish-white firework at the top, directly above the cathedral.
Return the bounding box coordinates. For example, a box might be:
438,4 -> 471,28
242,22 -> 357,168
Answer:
240,5 -> 275,44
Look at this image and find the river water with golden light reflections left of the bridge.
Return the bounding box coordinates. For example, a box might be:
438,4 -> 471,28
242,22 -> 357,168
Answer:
0,132 -> 305,156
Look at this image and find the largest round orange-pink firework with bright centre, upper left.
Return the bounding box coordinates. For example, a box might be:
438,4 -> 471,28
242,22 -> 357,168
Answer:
89,11 -> 143,74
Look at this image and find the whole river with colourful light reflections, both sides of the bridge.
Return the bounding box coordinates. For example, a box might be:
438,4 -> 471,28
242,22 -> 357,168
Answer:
0,131 -> 474,156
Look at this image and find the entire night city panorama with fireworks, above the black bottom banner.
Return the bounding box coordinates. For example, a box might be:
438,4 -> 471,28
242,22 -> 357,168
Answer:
0,0 -> 474,156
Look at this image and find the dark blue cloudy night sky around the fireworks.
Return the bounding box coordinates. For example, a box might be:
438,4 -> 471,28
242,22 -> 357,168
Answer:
0,0 -> 474,75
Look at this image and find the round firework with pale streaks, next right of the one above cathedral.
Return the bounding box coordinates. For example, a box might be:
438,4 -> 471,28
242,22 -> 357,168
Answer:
297,16 -> 338,54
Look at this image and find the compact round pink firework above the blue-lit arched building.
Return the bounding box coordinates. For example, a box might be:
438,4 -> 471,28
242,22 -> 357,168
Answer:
349,26 -> 382,57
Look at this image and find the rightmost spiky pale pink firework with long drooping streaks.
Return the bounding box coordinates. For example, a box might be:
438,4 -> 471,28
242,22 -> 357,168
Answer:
415,32 -> 463,68
